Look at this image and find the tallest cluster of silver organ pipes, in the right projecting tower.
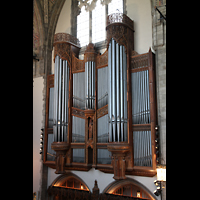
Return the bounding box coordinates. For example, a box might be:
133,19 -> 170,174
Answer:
108,38 -> 127,142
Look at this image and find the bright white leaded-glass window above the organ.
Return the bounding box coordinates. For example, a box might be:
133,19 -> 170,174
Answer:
77,0 -> 124,47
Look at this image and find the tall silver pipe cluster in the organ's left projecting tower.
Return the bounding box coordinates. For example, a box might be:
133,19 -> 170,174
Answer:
53,55 -> 69,142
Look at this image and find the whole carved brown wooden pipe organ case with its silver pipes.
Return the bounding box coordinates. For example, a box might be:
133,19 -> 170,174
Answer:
43,13 -> 157,179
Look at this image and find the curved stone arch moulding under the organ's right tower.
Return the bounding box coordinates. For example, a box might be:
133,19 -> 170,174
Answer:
102,178 -> 157,200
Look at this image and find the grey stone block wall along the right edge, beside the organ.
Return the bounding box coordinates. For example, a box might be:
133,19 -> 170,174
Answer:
152,0 -> 166,200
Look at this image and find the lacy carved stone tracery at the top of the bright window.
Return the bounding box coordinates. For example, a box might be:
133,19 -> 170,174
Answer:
78,0 -> 112,12
